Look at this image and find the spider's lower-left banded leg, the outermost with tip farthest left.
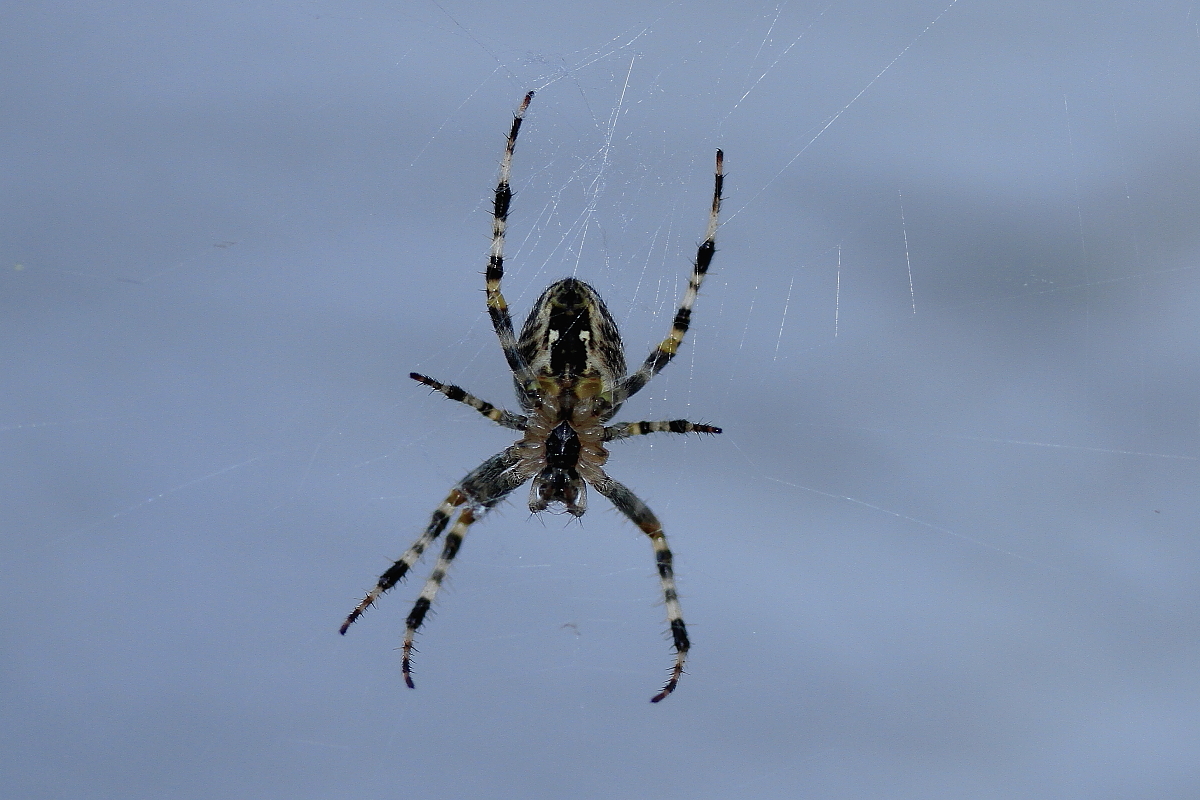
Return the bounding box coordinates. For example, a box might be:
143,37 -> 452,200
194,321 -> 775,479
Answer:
341,447 -> 528,636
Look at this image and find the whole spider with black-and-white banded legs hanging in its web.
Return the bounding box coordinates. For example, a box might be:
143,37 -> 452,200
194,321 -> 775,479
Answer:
341,91 -> 724,703
